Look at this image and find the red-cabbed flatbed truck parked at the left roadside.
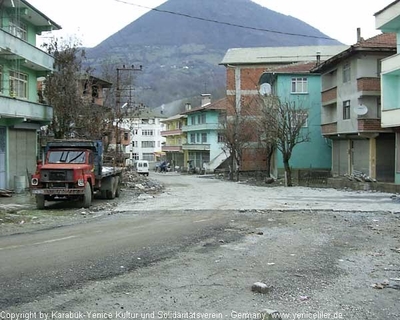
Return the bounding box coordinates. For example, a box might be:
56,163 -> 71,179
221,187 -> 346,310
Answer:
30,140 -> 123,209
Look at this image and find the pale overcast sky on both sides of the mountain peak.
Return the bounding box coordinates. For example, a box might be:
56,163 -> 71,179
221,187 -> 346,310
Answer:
27,0 -> 394,47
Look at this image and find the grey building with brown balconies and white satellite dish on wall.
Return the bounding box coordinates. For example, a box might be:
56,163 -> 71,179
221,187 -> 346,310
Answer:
313,32 -> 397,182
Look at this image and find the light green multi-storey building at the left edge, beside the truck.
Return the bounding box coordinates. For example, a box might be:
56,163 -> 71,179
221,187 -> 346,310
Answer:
0,0 -> 61,189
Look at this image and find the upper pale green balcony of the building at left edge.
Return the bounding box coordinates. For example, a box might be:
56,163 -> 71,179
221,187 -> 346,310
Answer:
0,29 -> 54,71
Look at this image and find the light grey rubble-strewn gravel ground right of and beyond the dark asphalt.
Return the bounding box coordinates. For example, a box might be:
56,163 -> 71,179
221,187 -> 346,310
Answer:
0,174 -> 400,319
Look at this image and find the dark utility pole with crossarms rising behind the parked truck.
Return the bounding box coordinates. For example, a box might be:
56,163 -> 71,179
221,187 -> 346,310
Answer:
114,65 -> 143,167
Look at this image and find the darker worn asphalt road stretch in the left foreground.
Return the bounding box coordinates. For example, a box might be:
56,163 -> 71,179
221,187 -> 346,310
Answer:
0,211 -> 234,310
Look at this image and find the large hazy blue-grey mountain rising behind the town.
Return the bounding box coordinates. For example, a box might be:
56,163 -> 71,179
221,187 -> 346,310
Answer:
86,0 -> 340,107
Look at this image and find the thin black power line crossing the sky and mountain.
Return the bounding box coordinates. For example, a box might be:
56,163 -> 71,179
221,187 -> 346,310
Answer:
114,0 -> 335,41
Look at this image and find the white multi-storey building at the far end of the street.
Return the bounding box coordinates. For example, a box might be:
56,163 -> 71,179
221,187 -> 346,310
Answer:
124,108 -> 167,165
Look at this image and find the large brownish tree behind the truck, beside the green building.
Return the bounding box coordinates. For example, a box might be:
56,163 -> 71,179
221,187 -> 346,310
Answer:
43,39 -> 108,139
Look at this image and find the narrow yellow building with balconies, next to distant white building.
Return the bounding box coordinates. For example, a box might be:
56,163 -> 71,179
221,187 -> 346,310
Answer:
161,112 -> 190,169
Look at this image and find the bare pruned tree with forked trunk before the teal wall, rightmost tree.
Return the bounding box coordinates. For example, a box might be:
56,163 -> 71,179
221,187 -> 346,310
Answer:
260,95 -> 310,186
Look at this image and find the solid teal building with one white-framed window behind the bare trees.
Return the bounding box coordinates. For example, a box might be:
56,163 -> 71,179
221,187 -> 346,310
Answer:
260,62 -> 332,172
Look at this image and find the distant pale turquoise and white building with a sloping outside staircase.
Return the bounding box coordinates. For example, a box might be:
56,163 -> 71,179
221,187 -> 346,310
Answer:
182,94 -> 227,172
